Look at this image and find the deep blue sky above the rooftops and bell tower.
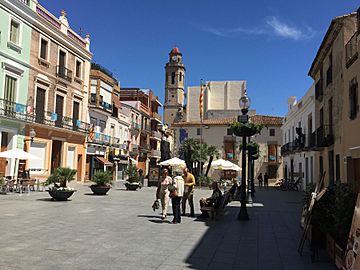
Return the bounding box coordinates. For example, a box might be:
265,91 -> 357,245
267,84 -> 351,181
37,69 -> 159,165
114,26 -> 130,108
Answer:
40,0 -> 360,115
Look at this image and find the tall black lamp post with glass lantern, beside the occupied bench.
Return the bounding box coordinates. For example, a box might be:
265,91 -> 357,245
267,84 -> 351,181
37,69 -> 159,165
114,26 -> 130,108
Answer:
238,92 -> 250,221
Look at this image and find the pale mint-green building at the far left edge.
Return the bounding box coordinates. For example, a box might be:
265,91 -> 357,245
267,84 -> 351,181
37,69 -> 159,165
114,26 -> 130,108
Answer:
0,0 -> 36,176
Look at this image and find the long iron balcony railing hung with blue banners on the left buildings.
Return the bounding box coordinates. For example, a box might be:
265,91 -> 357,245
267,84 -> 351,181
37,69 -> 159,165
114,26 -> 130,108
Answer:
0,99 -> 90,133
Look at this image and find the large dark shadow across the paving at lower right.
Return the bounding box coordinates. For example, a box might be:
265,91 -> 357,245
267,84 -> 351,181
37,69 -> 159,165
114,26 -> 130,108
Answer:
185,189 -> 336,270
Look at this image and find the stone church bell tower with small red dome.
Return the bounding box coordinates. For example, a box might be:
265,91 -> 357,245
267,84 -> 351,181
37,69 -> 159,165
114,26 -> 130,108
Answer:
164,47 -> 185,128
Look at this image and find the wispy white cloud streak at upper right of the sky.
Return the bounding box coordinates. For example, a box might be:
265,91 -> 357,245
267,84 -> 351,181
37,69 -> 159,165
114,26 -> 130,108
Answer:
200,16 -> 315,40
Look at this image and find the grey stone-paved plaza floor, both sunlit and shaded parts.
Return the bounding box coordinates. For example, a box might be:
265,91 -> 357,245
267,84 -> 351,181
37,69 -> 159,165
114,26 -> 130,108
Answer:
0,183 -> 335,270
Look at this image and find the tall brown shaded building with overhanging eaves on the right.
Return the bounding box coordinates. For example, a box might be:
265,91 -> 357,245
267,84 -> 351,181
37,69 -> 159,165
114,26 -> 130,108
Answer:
309,12 -> 360,185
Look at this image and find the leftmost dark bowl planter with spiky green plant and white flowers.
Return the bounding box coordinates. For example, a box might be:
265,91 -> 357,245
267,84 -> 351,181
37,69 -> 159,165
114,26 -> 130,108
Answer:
46,167 -> 76,201
